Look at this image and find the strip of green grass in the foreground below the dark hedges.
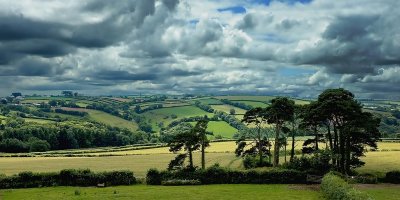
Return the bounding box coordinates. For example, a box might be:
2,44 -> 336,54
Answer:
0,185 -> 322,200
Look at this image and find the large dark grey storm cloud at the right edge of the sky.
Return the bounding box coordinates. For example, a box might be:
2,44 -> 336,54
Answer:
295,10 -> 400,74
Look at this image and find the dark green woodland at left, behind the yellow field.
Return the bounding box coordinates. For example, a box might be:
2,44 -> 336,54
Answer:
0,118 -> 152,153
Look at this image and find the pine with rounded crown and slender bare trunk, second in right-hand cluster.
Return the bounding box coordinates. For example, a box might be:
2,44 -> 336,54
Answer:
265,97 -> 294,167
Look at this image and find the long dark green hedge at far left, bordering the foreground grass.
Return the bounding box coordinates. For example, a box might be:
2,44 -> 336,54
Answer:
0,169 -> 136,189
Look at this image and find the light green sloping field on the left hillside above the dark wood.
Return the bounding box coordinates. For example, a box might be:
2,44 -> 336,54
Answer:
63,108 -> 138,131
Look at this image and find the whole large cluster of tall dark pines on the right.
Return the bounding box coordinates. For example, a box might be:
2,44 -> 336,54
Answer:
237,88 -> 380,174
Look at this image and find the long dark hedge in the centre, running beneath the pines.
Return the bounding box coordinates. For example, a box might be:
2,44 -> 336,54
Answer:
147,166 -> 307,185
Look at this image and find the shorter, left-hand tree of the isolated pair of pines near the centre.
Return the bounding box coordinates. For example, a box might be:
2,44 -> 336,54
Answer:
168,123 -> 201,169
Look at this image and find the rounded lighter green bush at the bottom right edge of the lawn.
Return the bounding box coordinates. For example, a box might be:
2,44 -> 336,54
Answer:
321,173 -> 371,200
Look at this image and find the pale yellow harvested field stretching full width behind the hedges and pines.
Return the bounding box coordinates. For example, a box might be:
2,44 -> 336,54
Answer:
0,141 -> 400,177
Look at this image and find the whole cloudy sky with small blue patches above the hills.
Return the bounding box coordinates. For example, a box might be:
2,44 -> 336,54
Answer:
0,0 -> 400,99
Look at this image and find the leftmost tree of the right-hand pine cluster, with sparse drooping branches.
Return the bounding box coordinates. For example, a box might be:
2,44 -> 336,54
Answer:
235,107 -> 271,166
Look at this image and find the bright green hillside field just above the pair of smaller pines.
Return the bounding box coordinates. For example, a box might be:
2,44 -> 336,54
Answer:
141,106 -> 214,131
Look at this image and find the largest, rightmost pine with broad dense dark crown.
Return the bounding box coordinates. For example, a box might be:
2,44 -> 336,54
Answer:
318,88 -> 380,174
